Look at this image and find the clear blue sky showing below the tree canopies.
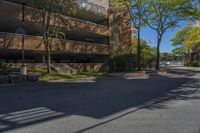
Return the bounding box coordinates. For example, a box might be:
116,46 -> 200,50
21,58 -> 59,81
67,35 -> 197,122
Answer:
141,21 -> 188,52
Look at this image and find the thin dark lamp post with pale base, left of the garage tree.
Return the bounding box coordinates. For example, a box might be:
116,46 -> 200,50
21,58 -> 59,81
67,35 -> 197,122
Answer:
20,2 -> 27,75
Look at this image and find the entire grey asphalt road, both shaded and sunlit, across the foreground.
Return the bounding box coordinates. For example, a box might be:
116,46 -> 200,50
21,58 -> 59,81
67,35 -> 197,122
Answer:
0,72 -> 200,133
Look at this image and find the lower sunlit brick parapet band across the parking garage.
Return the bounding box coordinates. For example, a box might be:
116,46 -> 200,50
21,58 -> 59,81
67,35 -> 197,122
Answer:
0,33 -> 109,55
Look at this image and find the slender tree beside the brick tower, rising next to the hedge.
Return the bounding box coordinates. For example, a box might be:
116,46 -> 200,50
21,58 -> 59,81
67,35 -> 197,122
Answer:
112,0 -> 147,70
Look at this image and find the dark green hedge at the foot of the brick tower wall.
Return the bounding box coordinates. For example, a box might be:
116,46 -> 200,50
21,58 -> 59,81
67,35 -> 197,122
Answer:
108,54 -> 136,71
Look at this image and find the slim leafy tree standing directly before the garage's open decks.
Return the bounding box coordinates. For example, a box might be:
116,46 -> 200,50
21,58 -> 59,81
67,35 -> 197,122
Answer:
28,0 -> 76,73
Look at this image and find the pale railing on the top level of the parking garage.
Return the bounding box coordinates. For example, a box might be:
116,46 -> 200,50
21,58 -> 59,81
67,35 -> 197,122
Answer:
77,0 -> 108,16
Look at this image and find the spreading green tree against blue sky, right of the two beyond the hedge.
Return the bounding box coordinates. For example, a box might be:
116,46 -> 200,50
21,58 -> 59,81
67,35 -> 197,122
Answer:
146,0 -> 199,70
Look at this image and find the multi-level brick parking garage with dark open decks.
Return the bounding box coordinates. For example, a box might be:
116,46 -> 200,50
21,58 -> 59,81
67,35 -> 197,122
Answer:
0,0 -> 131,68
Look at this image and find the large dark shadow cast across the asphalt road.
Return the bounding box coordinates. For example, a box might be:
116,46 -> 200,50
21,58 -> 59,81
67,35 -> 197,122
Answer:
0,73 -> 200,132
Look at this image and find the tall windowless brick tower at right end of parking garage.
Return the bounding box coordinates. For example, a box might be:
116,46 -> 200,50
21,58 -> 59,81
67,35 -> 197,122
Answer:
109,0 -> 132,53
